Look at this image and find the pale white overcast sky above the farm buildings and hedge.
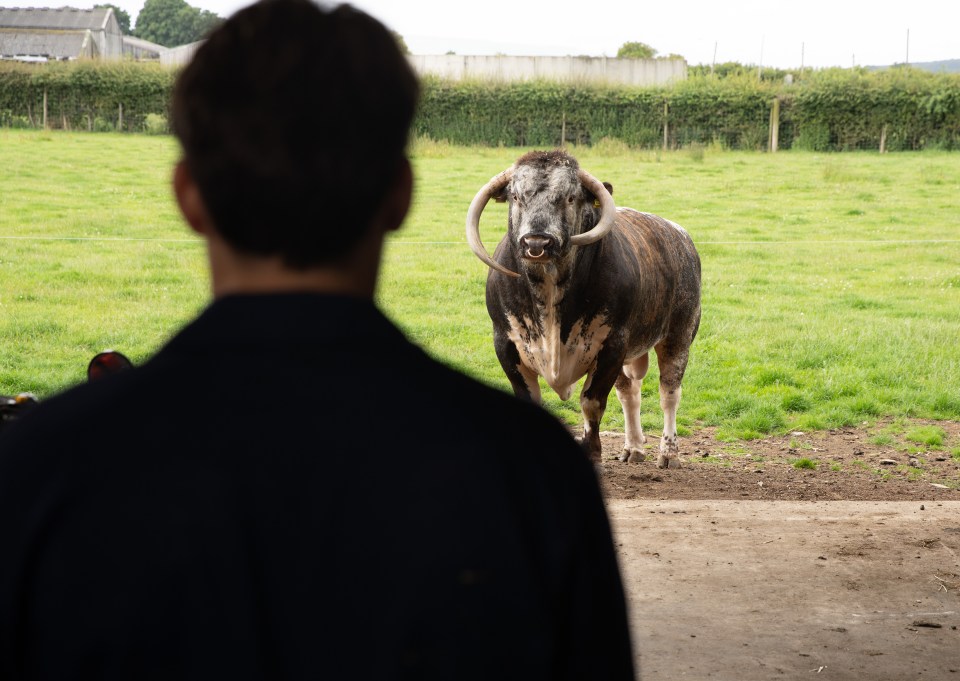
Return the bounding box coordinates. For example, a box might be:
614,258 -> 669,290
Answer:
9,0 -> 960,68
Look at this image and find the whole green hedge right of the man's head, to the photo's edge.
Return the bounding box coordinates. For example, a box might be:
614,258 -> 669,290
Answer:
416,69 -> 960,151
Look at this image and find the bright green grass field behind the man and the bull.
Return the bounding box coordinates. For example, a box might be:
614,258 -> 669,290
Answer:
0,131 -> 960,438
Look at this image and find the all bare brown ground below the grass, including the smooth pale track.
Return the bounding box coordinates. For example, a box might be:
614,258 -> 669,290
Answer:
600,422 -> 960,681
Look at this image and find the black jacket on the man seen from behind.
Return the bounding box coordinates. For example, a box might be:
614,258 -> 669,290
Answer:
0,294 -> 632,681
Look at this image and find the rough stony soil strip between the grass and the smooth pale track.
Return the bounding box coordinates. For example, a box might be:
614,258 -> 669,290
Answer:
600,420 -> 960,501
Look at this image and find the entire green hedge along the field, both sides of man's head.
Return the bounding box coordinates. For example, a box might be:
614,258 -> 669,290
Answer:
0,62 -> 960,151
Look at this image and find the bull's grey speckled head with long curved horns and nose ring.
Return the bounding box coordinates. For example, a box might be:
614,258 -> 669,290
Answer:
467,151 -> 617,277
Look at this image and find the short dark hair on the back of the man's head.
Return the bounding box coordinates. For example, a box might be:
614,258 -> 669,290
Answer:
173,0 -> 419,269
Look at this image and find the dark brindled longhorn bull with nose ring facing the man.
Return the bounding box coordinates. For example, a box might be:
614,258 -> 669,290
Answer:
467,150 -> 700,468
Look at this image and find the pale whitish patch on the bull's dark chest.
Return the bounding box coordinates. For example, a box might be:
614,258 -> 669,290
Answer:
507,300 -> 610,400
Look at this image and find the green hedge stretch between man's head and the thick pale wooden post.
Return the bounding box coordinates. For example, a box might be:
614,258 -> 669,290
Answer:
415,79 -> 776,148
